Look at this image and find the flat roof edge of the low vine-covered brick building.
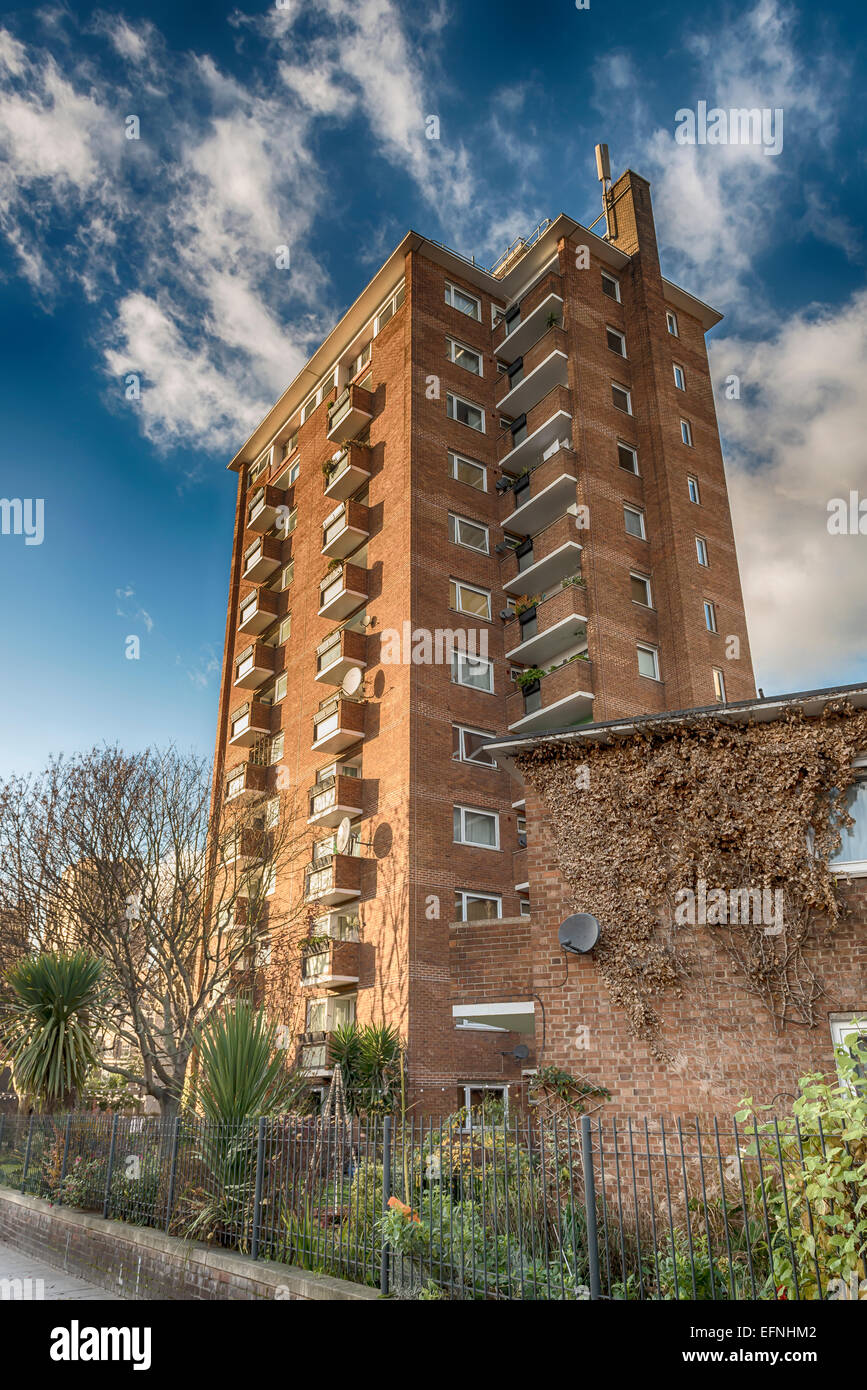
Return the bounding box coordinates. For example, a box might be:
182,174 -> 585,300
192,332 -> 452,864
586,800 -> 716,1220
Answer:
484,684 -> 867,753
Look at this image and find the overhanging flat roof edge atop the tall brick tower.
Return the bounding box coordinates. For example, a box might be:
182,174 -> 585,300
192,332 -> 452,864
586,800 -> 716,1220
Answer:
228,213 -> 723,471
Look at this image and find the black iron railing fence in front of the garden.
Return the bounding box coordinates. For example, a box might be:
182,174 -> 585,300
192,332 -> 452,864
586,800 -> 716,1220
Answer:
0,1113 -> 867,1300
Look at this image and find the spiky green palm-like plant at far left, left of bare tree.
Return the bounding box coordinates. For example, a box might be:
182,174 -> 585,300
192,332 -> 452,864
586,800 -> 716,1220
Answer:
3,951 -> 103,1109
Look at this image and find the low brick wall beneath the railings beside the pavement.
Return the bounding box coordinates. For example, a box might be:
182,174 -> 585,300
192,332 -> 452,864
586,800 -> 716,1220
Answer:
0,1187 -> 379,1301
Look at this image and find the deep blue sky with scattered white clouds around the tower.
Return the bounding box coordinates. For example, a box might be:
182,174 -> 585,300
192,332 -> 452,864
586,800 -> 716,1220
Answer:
0,0 -> 867,771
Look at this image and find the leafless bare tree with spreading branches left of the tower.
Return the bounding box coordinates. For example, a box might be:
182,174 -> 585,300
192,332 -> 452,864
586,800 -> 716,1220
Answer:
0,748 -> 308,1115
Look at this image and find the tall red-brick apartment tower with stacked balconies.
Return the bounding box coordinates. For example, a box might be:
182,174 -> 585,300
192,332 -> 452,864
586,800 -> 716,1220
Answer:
217,157 -> 754,1113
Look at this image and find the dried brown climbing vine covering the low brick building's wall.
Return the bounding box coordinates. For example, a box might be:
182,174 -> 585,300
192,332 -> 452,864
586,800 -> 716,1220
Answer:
517,701 -> 867,1061
